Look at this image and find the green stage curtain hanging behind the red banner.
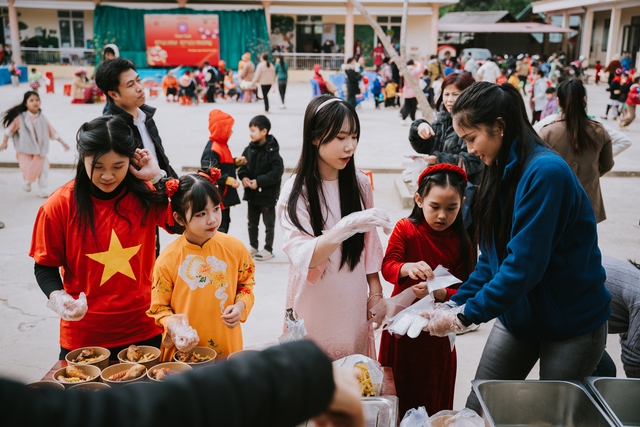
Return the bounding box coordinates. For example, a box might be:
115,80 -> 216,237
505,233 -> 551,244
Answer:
93,5 -> 269,69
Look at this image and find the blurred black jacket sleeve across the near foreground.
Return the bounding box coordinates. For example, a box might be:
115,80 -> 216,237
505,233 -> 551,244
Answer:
0,340 -> 335,427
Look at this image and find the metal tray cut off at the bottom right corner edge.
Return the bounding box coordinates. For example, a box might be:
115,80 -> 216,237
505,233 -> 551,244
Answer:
587,377 -> 640,427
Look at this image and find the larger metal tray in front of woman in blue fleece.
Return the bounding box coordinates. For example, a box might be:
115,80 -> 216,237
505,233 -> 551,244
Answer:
472,380 -> 615,427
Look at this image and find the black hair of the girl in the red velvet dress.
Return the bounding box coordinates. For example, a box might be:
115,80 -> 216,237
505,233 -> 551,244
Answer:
408,171 -> 471,275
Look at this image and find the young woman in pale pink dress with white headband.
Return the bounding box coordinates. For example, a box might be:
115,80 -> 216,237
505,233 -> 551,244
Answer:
277,95 -> 391,360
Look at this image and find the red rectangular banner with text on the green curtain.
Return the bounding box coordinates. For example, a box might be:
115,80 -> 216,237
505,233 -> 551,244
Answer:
144,14 -> 220,67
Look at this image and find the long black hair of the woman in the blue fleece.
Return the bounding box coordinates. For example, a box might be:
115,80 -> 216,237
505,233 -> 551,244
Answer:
452,82 -> 547,261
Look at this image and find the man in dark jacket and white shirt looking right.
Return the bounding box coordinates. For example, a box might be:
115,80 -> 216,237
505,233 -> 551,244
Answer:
96,58 -> 178,181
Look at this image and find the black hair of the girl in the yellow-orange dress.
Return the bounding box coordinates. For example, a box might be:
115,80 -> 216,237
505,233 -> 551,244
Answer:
171,168 -> 222,223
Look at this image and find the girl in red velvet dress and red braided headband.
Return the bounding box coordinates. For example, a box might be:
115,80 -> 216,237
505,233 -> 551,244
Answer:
380,163 -> 474,414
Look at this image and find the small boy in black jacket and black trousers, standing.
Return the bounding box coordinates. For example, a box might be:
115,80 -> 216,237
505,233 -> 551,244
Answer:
238,116 -> 284,261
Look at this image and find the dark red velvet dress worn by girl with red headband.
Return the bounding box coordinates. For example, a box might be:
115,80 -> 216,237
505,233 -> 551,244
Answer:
379,218 -> 473,418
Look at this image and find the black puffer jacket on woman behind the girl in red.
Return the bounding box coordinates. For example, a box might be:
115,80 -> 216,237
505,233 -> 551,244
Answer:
409,111 -> 484,185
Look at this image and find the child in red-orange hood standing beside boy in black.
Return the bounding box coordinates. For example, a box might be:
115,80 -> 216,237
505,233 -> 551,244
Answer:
200,110 -> 247,233
